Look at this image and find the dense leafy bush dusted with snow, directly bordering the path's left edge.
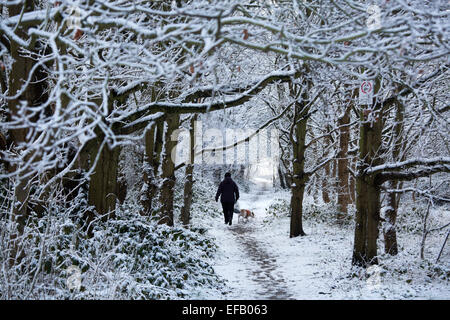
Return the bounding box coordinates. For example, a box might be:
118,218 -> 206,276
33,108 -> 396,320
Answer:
76,205 -> 222,299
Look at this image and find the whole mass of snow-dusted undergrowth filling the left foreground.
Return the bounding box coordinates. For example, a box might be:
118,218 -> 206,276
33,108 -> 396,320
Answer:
0,188 -> 222,299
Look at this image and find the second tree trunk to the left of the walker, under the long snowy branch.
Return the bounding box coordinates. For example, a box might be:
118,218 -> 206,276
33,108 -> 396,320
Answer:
159,114 -> 180,226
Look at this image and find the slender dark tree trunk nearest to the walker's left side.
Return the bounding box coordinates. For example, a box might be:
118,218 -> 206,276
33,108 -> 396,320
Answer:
181,115 -> 197,226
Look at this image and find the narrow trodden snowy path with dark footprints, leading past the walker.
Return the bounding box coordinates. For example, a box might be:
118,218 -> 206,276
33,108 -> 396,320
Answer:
214,181 -> 298,300
